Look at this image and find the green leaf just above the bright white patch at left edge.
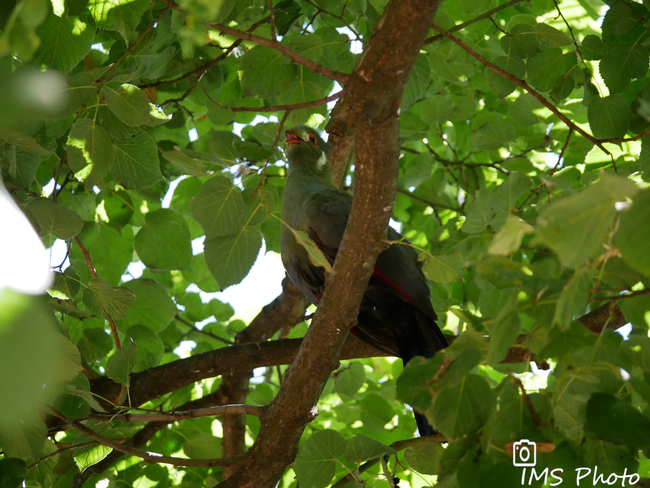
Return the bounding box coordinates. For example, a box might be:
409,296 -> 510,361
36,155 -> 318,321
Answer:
25,198 -> 83,240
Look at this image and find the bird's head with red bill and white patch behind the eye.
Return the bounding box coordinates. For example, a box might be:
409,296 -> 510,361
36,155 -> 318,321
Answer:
284,125 -> 330,172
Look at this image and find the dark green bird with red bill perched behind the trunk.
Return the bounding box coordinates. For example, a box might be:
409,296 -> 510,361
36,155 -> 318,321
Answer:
280,125 -> 447,436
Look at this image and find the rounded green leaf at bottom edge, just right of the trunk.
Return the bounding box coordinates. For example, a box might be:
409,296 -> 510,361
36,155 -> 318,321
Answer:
293,430 -> 346,488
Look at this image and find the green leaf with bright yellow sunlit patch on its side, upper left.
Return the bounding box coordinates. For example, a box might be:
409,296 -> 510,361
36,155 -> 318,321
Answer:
67,119 -> 115,185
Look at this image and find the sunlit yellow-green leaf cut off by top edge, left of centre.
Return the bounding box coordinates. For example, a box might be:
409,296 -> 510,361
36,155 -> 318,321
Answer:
88,0 -> 151,43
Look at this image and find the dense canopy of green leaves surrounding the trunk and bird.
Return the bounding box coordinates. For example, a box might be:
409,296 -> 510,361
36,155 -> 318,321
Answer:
0,0 -> 650,488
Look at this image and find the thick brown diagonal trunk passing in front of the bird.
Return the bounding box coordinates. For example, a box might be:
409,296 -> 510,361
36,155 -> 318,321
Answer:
222,0 -> 438,488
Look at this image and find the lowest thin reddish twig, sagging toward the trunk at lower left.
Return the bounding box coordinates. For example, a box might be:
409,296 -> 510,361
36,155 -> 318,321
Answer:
48,408 -> 248,468
